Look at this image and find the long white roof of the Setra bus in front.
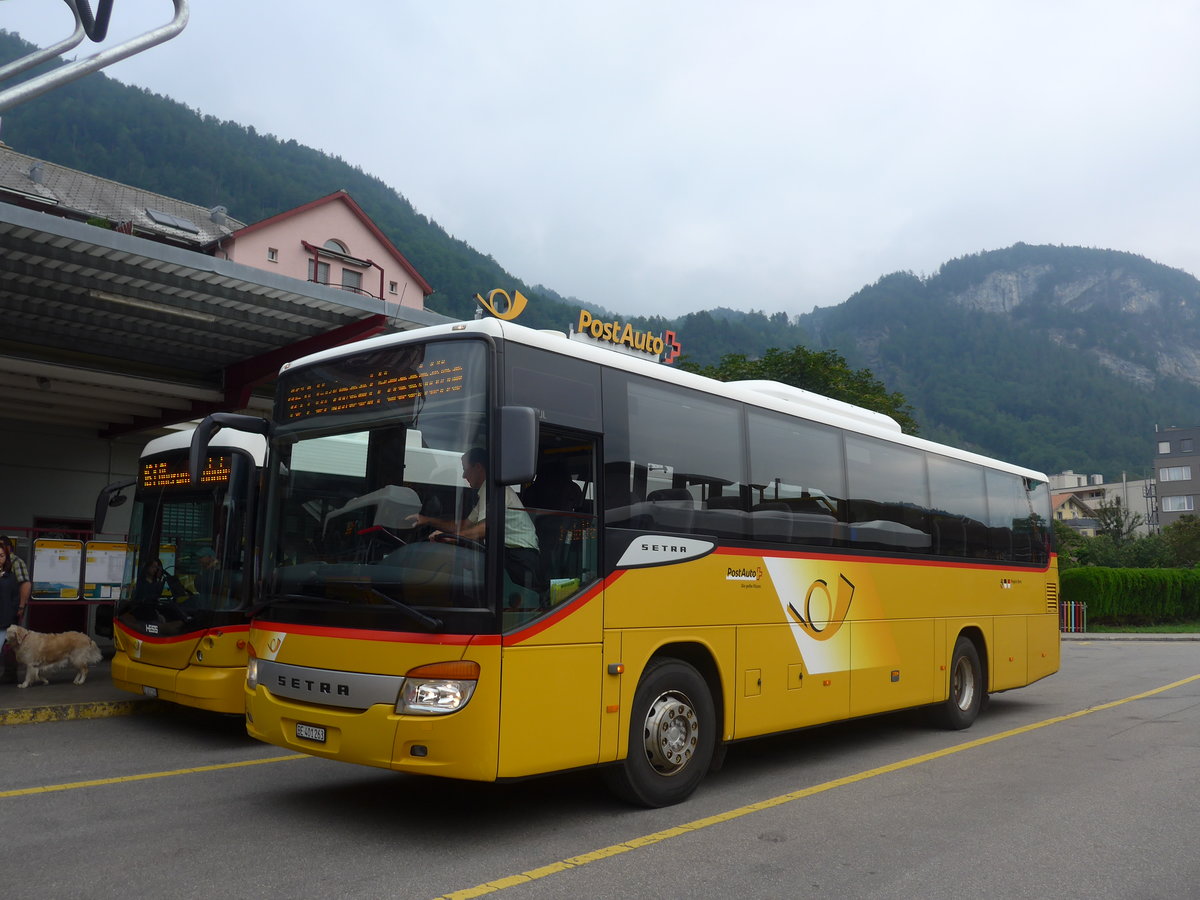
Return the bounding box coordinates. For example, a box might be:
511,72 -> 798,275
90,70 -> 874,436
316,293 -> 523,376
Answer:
281,317 -> 1048,481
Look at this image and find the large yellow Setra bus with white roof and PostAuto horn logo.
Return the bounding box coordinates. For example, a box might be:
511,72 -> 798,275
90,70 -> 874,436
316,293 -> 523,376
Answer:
193,319 -> 1058,806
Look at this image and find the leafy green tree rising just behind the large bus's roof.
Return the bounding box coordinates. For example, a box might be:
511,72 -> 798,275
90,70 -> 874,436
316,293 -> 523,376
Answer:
684,346 -> 918,434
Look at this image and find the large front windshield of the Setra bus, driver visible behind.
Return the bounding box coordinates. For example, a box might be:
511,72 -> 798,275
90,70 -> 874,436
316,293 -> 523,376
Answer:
262,340 -> 500,634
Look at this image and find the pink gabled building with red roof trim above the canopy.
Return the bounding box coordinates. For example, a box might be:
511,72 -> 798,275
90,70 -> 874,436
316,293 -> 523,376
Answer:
216,191 -> 433,310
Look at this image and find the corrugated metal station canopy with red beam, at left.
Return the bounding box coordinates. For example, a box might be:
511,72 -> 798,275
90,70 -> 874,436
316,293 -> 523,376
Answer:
0,203 -> 448,437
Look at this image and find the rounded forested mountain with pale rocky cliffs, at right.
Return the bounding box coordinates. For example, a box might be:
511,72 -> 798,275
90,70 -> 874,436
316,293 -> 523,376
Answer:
800,244 -> 1200,479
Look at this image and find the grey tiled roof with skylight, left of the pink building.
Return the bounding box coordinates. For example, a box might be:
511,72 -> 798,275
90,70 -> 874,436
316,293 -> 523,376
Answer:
0,145 -> 242,250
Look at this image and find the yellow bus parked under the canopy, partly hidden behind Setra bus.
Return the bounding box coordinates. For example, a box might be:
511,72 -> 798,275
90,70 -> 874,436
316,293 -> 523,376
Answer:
97,430 -> 266,714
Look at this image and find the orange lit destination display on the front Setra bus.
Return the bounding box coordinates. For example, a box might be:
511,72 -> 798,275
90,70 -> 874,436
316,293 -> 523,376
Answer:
284,359 -> 464,421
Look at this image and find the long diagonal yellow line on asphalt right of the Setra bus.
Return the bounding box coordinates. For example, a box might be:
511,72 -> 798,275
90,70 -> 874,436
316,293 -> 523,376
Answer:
438,674 -> 1200,900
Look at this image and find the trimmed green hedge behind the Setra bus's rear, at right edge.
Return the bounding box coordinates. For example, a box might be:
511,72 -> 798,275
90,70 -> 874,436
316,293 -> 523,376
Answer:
1060,566 -> 1200,625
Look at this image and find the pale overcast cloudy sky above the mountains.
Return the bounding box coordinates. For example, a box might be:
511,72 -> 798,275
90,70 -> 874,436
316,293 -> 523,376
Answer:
0,0 -> 1200,316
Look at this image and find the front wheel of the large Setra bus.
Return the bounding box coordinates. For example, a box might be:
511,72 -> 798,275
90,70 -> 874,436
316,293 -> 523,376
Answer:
605,660 -> 716,806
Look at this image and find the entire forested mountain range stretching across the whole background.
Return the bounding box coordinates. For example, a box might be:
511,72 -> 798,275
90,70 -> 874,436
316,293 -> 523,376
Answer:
0,31 -> 1200,479
